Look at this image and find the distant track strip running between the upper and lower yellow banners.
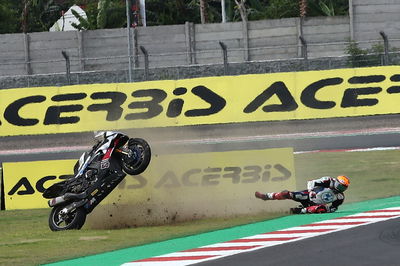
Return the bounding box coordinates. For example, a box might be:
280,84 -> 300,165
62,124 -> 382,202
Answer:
0,114 -> 400,163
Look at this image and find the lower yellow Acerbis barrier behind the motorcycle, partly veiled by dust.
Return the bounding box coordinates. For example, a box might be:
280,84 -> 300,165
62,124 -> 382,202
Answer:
3,148 -> 296,224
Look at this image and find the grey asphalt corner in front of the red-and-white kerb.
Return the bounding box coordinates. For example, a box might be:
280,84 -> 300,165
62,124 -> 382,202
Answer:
194,217 -> 400,266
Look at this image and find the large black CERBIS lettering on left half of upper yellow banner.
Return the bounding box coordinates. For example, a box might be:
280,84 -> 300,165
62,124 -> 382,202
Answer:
0,85 -> 226,126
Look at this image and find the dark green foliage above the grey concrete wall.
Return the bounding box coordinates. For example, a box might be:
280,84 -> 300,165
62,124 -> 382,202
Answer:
0,0 -> 348,33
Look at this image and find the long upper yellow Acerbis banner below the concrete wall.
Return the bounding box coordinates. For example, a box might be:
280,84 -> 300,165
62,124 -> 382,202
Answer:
0,66 -> 400,136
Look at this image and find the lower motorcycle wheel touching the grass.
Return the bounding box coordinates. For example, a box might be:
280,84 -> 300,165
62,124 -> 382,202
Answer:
49,205 -> 86,231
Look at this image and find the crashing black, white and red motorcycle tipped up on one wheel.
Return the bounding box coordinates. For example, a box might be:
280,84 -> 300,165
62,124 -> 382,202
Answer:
43,131 -> 151,231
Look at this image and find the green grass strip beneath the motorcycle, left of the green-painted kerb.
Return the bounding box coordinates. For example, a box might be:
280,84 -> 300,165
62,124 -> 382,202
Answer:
0,209 -> 282,266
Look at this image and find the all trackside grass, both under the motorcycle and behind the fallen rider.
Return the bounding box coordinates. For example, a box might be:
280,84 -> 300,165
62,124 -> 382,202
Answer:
0,151 -> 400,265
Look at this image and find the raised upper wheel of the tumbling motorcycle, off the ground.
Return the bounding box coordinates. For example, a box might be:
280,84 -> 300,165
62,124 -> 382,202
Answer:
121,138 -> 151,175
